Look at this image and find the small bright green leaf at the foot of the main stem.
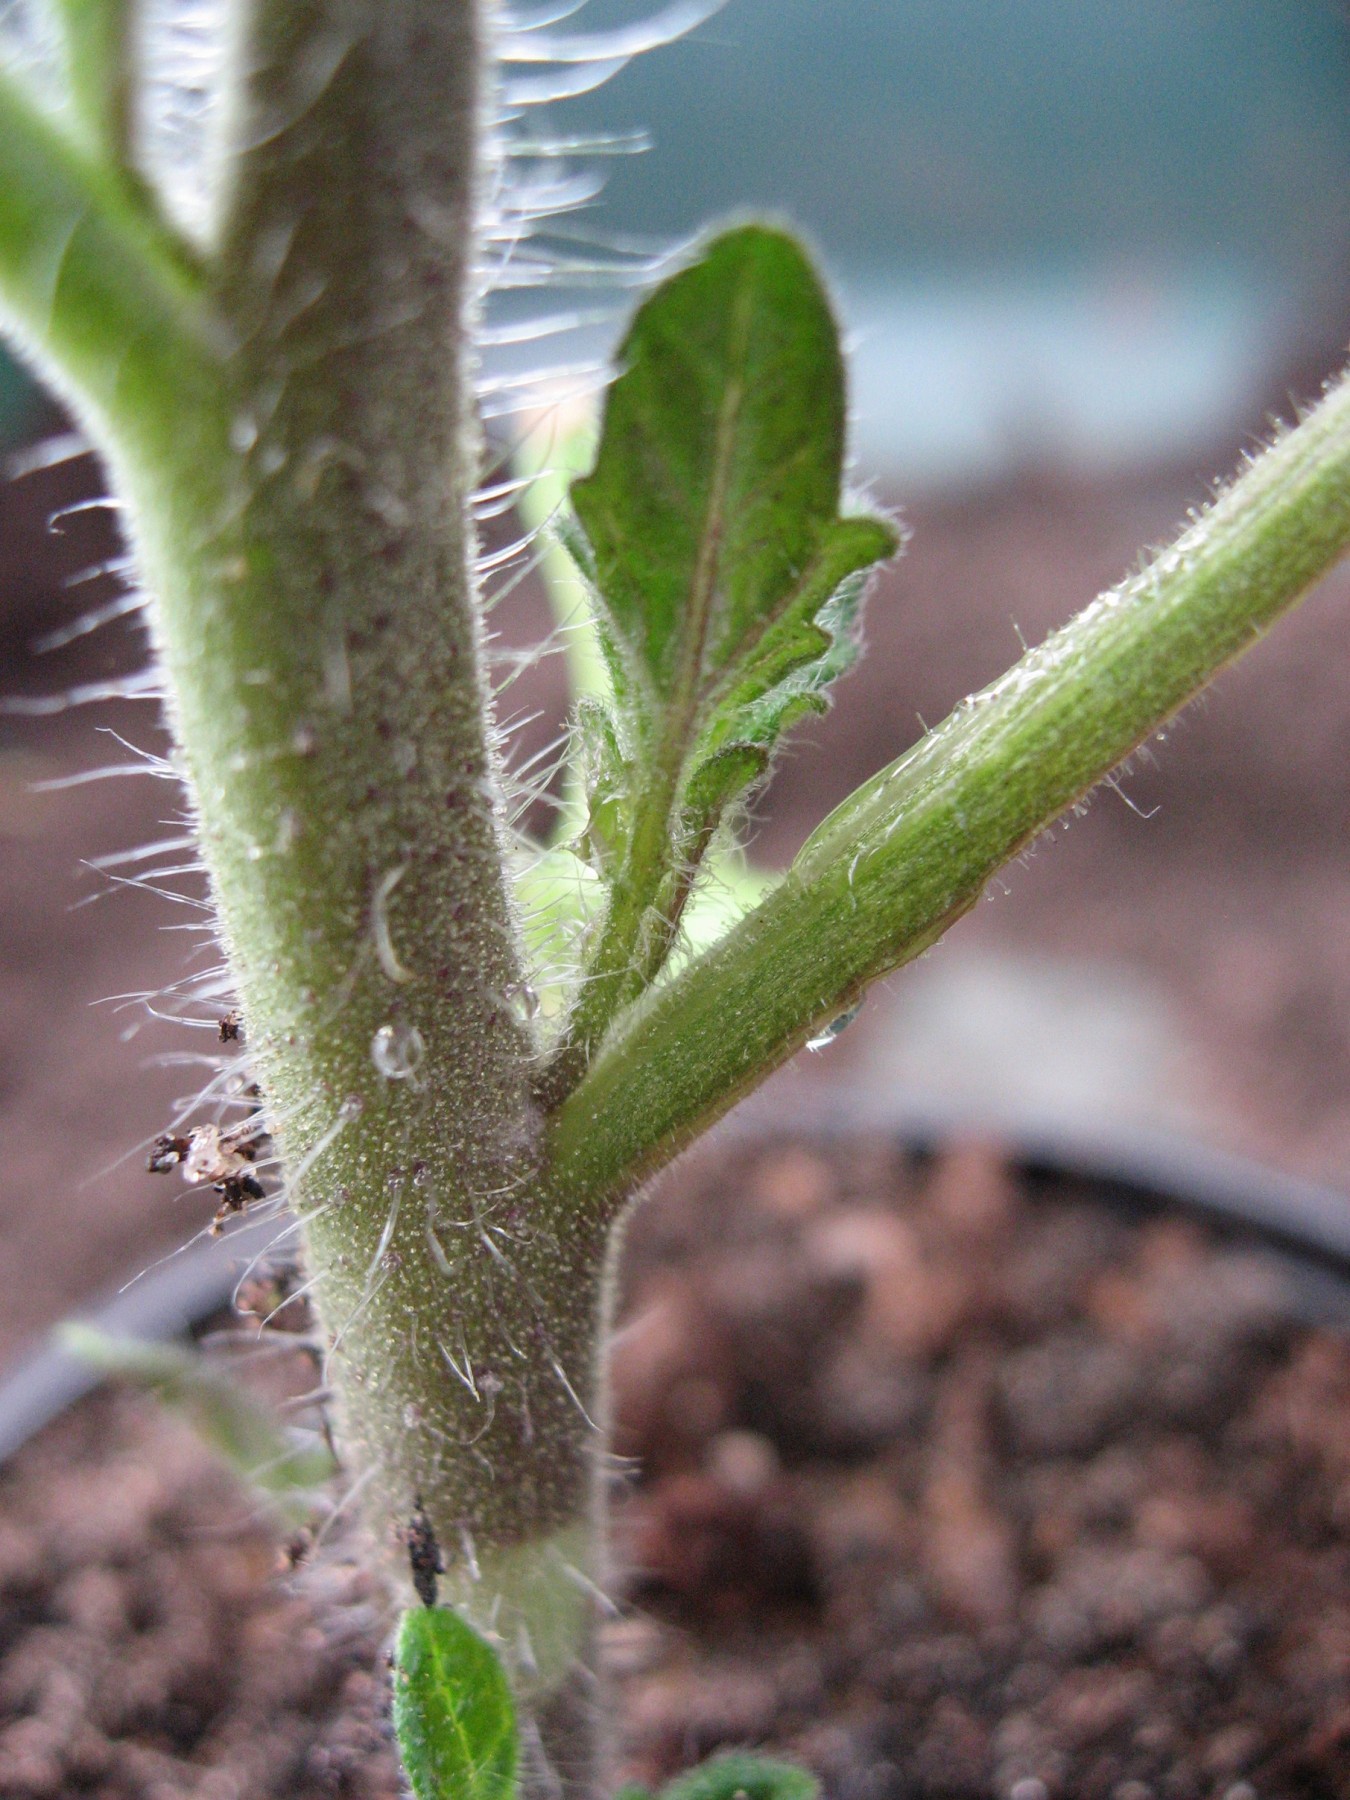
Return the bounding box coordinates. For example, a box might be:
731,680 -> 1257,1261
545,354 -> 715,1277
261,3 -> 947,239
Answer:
394,1606 -> 517,1800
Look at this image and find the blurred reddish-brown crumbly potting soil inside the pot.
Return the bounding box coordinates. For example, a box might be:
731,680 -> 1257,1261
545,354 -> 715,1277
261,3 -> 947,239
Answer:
0,1138 -> 1350,1800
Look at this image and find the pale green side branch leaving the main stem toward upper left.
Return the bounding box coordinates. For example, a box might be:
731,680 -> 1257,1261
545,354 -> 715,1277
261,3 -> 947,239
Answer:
0,74 -> 218,459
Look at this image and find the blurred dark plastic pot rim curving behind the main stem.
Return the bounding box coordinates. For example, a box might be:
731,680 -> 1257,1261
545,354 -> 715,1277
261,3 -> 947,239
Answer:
0,1084 -> 1350,1462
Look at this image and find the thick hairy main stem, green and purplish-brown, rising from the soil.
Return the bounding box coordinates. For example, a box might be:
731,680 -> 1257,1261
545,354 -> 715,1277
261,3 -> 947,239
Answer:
94,0 -> 605,1795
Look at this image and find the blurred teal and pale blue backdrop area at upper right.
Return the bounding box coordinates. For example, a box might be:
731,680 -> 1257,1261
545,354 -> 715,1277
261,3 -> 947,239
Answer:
493,0 -> 1350,490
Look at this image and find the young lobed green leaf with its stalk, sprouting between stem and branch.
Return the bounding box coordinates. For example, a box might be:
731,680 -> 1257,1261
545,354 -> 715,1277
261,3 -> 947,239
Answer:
562,225 -> 896,1073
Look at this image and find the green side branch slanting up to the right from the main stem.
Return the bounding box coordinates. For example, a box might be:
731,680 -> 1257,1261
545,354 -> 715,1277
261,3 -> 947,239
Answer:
551,367 -> 1350,1210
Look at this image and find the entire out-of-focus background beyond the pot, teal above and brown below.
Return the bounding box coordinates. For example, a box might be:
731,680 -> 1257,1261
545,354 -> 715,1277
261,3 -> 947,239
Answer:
0,0 -> 1350,1355
